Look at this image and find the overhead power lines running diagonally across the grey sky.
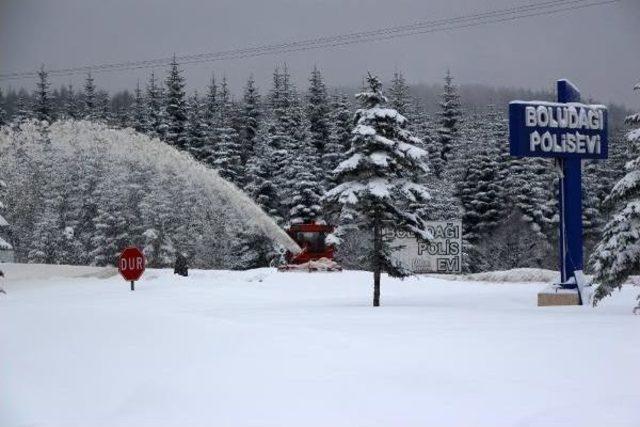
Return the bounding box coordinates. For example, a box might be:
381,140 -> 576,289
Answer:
0,0 -> 620,81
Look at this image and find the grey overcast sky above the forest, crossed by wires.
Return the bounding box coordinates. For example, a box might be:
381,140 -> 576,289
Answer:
0,0 -> 640,107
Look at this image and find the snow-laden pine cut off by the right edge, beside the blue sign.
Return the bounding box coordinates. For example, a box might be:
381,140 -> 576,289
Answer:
590,83 -> 640,313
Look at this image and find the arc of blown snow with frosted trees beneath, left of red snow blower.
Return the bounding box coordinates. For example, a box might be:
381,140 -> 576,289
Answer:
0,121 -> 295,268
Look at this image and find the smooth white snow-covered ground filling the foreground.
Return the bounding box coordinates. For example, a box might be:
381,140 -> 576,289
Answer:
0,265 -> 640,427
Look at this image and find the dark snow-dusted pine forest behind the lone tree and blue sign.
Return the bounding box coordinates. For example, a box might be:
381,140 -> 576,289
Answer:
0,61 -> 627,271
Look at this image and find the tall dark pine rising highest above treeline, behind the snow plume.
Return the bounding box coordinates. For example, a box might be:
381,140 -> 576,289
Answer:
165,55 -> 187,150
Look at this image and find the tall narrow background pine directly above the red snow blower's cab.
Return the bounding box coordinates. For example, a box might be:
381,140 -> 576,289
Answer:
306,66 -> 331,182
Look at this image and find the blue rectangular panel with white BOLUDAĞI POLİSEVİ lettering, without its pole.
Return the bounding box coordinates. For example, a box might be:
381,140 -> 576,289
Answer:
509,101 -> 608,159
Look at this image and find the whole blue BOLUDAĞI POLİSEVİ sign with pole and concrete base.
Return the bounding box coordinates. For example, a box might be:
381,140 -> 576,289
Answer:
509,80 -> 608,305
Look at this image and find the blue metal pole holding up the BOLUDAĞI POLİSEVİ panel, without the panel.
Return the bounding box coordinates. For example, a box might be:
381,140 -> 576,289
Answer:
558,80 -> 582,288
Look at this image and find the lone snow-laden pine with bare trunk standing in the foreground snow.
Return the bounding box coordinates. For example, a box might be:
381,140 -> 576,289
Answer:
325,74 -> 431,306
